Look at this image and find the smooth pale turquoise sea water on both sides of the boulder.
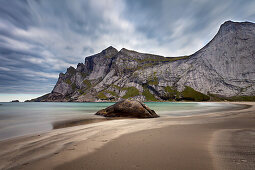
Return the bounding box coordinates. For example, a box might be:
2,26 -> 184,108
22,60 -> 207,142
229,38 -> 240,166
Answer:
0,102 -> 234,140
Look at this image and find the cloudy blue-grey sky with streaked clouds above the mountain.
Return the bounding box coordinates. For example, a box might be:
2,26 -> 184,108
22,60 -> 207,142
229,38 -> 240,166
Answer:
0,0 -> 255,102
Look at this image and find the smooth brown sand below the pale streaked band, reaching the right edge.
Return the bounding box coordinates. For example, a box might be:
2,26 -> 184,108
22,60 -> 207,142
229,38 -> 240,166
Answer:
55,102 -> 255,170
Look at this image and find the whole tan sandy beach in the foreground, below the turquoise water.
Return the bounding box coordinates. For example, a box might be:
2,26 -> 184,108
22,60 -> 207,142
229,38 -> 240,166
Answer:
0,102 -> 255,170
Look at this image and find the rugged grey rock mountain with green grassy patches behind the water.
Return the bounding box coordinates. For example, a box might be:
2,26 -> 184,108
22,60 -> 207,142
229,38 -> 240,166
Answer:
27,21 -> 255,102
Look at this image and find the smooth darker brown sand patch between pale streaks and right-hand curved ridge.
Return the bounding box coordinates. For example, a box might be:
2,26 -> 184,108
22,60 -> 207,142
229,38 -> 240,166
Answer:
56,125 -> 213,170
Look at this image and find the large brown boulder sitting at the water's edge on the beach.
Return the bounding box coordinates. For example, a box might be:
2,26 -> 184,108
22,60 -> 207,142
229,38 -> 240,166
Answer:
96,99 -> 159,118
